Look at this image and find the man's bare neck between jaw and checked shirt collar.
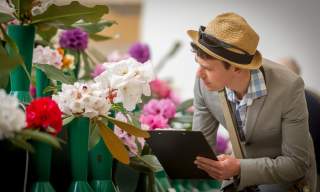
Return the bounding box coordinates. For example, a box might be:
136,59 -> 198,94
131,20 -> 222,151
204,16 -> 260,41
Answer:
228,70 -> 251,100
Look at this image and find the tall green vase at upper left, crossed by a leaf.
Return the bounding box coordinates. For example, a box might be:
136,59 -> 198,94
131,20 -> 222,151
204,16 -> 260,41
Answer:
7,25 -> 35,103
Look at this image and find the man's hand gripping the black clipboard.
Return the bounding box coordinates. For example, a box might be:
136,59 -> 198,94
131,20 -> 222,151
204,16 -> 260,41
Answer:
194,155 -> 240,180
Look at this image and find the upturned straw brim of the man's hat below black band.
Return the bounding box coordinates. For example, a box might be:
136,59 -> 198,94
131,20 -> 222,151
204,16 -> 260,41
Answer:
187,30 -> 262,69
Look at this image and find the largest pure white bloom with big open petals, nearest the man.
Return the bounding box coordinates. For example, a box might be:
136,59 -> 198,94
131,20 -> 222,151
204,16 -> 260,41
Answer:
94,58 -> 154,111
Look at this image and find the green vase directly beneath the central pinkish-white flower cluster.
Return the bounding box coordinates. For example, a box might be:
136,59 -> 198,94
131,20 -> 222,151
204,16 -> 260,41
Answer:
68,117 -> 94,192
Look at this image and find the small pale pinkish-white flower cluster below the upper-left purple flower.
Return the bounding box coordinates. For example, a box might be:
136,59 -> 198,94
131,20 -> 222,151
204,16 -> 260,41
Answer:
32,45 -> 63,69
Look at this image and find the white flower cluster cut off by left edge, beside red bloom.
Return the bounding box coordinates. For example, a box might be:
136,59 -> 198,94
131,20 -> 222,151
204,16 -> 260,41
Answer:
0,90 -> 26,140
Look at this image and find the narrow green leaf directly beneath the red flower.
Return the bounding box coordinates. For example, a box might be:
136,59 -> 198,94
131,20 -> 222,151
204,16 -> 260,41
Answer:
18,129 -> 61,148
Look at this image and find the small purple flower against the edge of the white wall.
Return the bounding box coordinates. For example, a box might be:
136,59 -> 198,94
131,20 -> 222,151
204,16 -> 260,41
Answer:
129,43 -> 150,63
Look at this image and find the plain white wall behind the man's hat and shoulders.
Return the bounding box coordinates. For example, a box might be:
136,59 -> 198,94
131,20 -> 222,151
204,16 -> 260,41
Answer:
141,0 -> 320,98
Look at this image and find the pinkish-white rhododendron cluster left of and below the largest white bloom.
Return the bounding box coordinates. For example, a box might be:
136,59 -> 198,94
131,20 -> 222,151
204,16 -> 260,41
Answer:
52,82 -> 111,118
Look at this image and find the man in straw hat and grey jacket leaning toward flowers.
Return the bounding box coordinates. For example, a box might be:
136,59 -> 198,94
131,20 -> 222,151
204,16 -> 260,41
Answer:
188,13 -> 315,191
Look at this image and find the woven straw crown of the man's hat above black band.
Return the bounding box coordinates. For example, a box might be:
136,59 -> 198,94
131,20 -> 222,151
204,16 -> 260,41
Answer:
204,13 -> 259,55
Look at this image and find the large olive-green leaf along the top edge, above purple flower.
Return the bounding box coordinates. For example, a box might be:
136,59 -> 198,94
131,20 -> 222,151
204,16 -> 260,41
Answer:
32,1 -> 109,26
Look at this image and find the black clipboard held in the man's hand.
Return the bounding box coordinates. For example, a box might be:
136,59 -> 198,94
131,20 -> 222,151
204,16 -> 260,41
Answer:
146,130 -> 217,179
